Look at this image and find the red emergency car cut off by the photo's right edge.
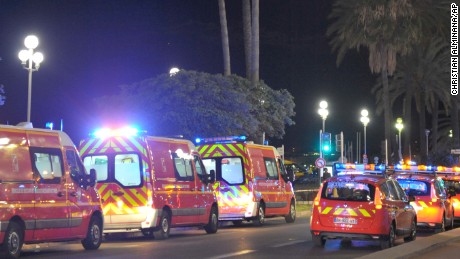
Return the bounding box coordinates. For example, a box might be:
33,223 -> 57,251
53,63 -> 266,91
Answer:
436,166 -> 460,221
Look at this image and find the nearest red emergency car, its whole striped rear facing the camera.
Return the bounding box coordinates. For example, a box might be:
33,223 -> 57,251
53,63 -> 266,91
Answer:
310,164 -> 417,249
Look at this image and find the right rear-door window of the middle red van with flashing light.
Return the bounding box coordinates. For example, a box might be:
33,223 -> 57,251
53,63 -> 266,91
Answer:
114,154 -> 142,187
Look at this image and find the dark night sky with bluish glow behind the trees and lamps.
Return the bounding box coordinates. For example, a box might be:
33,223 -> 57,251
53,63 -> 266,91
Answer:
0,0 -> 380,158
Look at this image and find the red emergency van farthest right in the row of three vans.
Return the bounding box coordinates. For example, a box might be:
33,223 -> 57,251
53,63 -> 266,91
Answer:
196,136 -> 296,225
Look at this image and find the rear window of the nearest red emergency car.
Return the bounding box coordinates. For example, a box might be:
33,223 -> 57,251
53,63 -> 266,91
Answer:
321,181 -> 375,201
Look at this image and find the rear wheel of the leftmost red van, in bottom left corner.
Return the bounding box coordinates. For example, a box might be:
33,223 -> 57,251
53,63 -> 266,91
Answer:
1,222 -> 24,258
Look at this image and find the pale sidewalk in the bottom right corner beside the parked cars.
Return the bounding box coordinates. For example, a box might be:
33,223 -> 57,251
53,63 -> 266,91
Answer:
359,228 -> 460,259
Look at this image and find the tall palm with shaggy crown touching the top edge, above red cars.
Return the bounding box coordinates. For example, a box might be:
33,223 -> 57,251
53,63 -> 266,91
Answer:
327,0 -> 421,164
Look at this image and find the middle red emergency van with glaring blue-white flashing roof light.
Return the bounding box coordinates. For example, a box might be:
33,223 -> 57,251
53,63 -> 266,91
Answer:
80,127 -> 218,239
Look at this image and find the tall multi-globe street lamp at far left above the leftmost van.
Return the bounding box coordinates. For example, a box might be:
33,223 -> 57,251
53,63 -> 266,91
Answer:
18,35 -> 43,122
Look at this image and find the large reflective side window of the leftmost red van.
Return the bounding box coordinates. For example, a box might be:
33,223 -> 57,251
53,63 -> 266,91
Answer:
29,147 -> 64,183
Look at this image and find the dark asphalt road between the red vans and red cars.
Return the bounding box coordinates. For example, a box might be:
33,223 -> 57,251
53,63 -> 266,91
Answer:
16,215 -> 444,259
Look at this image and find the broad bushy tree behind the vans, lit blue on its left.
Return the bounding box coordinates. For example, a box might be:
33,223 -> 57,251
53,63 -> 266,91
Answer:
96,70 -> 295,142
